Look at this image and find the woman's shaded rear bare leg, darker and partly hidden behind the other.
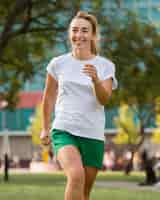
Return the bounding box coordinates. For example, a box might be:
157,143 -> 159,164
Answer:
84,167 -> 98,200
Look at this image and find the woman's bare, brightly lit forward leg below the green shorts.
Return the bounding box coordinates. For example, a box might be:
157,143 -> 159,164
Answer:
58,145 -> 85,200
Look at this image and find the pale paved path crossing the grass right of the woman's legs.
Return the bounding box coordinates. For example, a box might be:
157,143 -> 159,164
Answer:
95,181 -> 160,192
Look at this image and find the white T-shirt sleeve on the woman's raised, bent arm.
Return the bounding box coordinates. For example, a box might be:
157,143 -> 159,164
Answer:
102,63 -> 118,90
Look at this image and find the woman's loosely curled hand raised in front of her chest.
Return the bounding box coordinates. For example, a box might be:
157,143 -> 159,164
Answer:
83,64 -> 100,83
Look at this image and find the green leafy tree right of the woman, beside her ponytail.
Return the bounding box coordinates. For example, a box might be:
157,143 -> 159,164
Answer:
97,8 -> 160,146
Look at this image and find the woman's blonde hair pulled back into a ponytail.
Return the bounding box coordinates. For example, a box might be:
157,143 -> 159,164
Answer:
69,11 -> 99,55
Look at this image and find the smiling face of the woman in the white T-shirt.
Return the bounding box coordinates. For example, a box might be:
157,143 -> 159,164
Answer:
69,18 -> 94,51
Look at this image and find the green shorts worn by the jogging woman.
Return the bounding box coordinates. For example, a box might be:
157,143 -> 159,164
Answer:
51,129 -> 104,169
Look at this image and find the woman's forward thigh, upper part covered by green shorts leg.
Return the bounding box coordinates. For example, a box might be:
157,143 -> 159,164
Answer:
51,129 -> 84,175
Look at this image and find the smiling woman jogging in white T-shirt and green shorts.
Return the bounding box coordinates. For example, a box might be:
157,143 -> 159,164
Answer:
41,12 -> 117,200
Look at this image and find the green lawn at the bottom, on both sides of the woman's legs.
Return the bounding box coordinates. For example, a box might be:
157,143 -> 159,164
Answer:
0,173 -> 160,200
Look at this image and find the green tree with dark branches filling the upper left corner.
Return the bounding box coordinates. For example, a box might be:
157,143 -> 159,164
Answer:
0,0 -> 81,107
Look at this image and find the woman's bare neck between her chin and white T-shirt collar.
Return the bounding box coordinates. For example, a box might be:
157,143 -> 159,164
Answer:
72,49 -> 95,60
